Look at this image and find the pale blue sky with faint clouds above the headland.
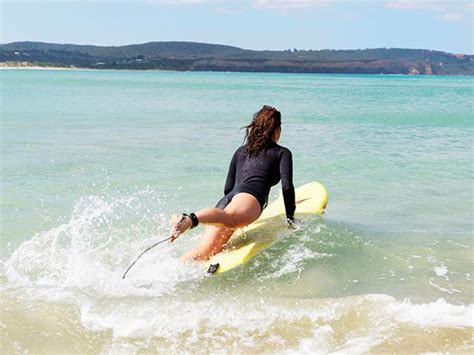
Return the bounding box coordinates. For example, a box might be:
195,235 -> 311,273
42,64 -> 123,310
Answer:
0,0 -> 474,54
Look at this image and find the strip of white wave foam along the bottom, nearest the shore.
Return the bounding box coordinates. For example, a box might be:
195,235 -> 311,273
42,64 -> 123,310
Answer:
72,295 -> 474,353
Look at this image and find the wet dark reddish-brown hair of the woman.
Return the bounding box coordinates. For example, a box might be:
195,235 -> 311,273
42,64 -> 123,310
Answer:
242,105 -> 281,155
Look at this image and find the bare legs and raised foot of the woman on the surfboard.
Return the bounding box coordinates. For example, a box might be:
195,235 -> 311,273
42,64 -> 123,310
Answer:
172,192 -> 262,260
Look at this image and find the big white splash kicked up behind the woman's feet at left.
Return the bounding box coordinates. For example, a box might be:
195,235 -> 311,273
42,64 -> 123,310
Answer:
3,192 -> 201,297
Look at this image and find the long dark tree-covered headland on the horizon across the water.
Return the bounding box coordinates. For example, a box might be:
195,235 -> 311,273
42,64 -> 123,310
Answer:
0,42 -> 474,75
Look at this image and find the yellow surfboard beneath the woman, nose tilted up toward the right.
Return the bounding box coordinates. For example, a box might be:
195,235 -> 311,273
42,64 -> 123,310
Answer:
205,181 -> 328,273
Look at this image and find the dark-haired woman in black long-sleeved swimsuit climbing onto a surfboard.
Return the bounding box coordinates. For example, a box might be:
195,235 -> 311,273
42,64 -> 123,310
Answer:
170,106 -> 296,260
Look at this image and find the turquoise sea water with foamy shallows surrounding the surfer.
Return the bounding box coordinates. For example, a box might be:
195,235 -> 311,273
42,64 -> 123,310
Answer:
0,70 -> 474,354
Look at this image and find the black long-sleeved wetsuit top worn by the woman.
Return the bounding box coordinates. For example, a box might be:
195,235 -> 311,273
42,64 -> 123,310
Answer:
216,143 -> 296,219
